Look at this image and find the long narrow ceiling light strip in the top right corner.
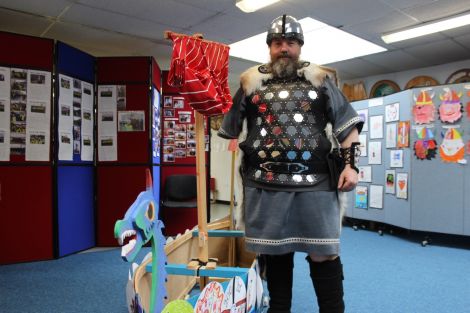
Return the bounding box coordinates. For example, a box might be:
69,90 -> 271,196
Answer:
382,14 -> 470,43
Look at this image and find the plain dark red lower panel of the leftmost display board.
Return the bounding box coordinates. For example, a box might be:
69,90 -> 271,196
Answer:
0,166 -> 53,264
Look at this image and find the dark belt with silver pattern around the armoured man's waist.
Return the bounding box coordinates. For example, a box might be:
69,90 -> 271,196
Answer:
259,162 -> 329,174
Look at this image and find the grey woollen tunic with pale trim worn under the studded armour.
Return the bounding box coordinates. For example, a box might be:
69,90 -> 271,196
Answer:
219,65 -> 362,255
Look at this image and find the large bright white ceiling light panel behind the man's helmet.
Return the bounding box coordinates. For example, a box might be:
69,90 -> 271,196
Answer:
230,17 -> 387,65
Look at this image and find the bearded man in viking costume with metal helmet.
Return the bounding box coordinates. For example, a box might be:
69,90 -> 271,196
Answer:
219,15 -> 363,313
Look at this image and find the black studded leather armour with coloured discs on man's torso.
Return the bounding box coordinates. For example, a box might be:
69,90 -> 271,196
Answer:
240,78 -> 331,186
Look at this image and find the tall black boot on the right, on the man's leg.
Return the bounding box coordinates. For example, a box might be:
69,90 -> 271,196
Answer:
306,256 -> 344,313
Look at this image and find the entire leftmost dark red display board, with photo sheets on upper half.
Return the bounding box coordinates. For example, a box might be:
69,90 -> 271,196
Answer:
0,32 -> 54,264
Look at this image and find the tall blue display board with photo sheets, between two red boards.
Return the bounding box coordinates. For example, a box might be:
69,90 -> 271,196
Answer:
54,42 -> 95,257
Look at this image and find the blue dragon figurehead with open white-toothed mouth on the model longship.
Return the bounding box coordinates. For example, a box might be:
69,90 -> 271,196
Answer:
114,169 -> 166,313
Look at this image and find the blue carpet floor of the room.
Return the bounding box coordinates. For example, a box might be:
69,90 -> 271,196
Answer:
0,227 -> 470,313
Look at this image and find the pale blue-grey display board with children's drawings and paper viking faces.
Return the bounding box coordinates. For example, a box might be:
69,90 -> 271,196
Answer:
346,84 -> 470,235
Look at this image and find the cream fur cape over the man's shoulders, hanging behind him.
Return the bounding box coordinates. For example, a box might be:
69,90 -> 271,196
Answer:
233,62 -> 347,230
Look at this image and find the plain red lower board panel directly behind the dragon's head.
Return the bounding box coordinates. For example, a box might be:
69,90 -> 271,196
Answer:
97,166 -> 148,247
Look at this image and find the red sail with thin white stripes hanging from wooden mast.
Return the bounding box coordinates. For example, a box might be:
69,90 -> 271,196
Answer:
168,33 -> 232,116
